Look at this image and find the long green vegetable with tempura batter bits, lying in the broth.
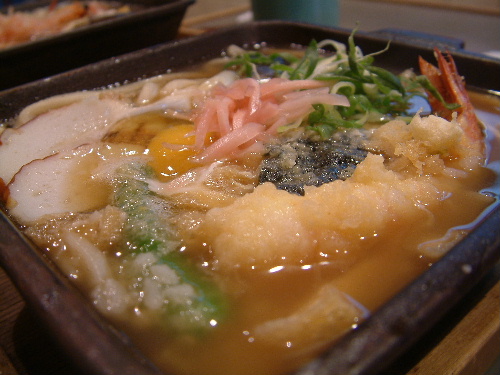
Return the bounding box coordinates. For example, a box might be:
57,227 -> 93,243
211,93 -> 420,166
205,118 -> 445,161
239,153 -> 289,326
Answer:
114,164 -> 226,333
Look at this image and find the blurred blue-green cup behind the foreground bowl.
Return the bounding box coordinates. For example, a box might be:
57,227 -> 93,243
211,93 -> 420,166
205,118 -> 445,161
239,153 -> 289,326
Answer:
252,0 -> 340,26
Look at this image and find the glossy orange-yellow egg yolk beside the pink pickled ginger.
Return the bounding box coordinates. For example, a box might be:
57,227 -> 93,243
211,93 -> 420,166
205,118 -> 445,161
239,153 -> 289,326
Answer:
148,123 -> 204,181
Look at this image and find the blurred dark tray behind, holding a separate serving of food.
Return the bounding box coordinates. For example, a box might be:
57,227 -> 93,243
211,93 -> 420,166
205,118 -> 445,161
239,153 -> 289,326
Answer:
0,0 -> 195,90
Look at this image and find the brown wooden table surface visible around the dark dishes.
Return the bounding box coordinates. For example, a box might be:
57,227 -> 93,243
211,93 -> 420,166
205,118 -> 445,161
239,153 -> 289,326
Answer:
0,5 -> 500,375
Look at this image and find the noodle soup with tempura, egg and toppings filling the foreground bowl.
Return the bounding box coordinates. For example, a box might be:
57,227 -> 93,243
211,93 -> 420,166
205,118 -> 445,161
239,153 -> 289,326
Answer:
0,38 -> 495,374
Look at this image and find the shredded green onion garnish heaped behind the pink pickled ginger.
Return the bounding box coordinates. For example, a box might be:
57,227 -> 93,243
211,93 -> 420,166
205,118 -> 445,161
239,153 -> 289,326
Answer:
226,33 -> 459,137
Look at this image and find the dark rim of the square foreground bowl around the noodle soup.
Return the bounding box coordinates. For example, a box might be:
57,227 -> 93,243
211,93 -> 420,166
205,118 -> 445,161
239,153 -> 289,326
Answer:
0,21 -> 500,375
